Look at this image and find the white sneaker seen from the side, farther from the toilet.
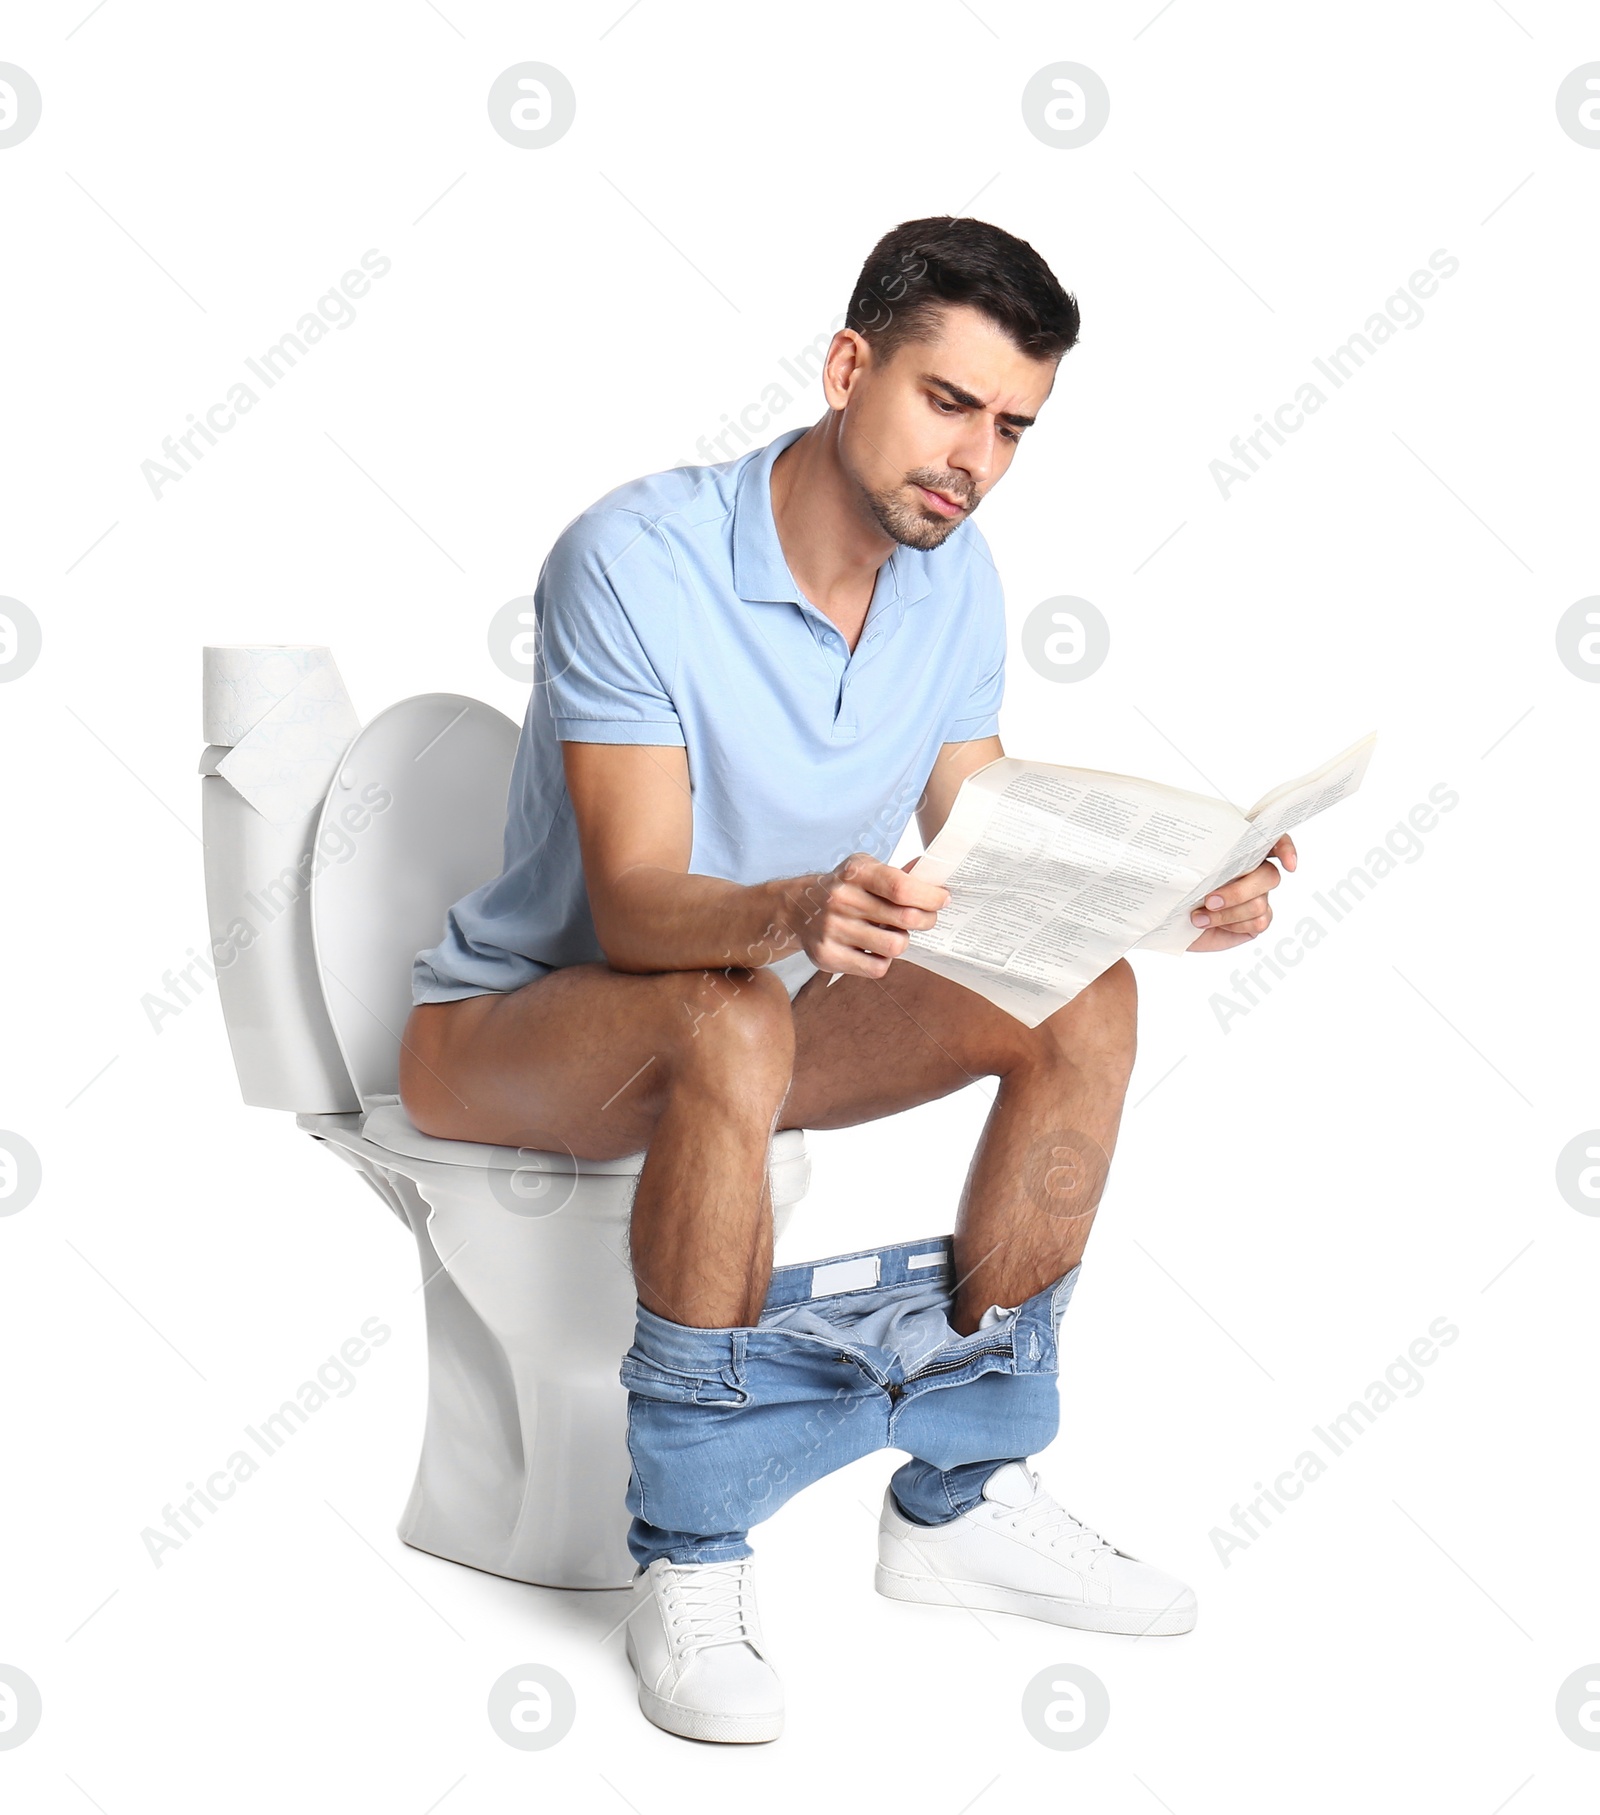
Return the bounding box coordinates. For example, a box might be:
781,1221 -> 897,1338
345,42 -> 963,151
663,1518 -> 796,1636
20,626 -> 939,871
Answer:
876,1463 -> 1195,1637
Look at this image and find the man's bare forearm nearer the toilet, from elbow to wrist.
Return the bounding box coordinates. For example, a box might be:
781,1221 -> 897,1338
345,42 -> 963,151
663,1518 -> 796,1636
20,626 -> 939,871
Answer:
595,864 -> 807,971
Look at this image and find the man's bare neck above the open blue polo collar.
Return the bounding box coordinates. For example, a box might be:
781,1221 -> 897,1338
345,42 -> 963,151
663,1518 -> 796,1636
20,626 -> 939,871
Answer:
771,410 -> 896,650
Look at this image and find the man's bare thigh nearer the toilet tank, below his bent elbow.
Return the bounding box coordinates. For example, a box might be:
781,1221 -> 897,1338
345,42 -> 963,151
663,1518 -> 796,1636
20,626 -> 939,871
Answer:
399,964 -> 754,1160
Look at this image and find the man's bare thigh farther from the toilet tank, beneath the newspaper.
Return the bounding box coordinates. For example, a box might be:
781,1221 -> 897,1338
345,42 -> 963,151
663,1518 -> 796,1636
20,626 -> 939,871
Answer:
778,960 -> 1036,1129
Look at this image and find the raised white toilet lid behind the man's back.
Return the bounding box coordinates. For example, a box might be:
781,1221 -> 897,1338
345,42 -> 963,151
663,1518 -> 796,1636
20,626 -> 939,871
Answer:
310,693 -> 517,1109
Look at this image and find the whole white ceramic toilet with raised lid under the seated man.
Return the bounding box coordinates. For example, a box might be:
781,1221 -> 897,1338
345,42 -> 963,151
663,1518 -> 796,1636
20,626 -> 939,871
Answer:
200,678 -> 809,1588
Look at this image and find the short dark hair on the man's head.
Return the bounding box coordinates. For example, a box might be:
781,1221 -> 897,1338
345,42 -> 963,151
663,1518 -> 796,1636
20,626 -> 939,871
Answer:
845,214 -> 1078,359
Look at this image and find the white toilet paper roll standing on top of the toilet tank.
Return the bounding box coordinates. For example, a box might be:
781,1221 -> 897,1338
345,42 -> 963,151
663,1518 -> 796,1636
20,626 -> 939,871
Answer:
203,643 -> 361,824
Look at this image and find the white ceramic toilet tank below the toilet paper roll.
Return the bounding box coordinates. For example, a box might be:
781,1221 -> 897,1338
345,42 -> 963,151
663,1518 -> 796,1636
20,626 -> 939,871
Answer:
200,744 -> 361,1114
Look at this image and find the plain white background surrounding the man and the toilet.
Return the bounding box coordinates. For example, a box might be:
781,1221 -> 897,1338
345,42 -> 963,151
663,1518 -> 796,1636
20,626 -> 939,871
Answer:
0,0 -> 1600,1815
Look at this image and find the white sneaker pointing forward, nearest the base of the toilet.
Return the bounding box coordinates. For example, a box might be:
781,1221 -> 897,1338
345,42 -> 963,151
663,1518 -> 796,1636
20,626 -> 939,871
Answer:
624,1557 -> 784,1742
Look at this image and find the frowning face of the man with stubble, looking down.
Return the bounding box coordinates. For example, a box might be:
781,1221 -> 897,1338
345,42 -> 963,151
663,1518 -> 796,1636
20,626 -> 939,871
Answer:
840,303 -> 1058,548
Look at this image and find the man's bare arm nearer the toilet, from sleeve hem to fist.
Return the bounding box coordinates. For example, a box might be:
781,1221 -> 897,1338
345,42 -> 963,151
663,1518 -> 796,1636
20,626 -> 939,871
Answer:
561,742 -> 949,976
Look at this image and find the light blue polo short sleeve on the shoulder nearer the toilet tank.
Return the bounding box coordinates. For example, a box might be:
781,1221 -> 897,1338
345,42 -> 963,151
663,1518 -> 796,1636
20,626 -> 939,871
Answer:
533,510 -> 684,744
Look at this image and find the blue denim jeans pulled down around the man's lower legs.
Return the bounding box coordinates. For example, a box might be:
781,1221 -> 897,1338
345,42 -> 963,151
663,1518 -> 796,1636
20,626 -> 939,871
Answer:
620,1236 -> 1078,1568
